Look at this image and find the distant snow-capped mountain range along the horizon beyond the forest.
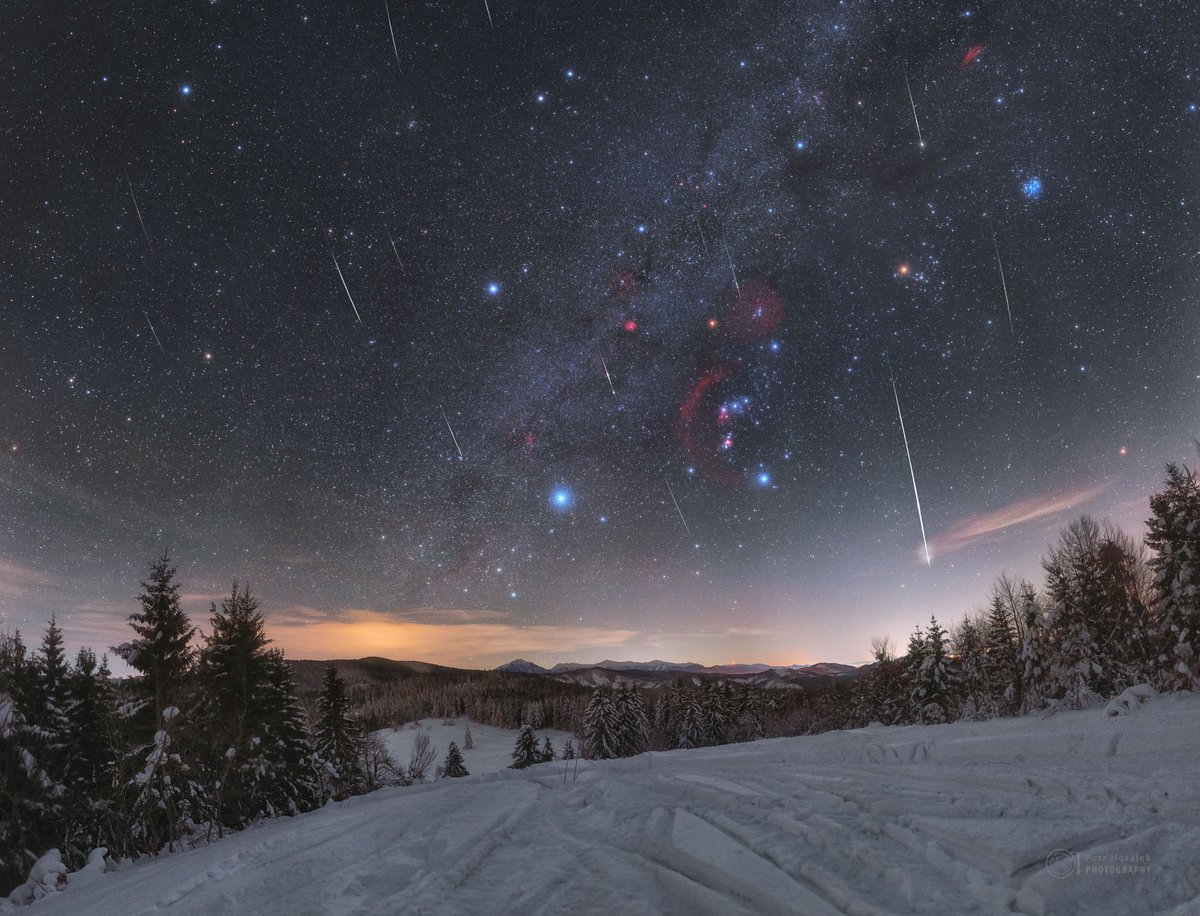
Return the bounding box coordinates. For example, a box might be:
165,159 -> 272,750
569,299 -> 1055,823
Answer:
496,658 -> 870,689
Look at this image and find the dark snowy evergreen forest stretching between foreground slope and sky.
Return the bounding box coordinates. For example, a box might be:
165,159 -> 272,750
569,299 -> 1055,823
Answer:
0,466 -> 1200,894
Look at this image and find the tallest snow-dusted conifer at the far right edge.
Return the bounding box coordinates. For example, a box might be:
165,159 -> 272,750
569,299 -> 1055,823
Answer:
1146,465 -> 1200,690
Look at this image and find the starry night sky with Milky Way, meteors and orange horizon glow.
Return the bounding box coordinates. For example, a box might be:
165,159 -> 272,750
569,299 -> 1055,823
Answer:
0,0 -> 1200,666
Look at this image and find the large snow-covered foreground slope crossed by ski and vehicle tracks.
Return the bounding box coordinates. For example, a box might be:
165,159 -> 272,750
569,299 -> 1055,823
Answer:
18,695 -> 1200,916
